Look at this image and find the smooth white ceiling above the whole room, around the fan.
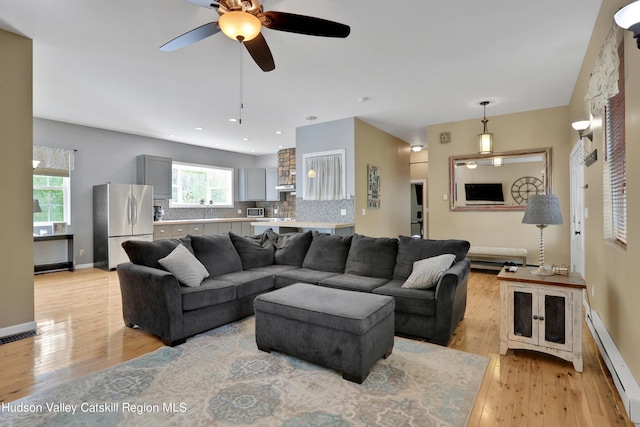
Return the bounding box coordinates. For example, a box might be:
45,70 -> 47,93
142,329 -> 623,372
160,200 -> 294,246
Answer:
0,0 -> 601,155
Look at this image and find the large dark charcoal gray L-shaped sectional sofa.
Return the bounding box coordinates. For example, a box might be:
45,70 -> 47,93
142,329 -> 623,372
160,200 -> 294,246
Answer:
117,230 -> 470,345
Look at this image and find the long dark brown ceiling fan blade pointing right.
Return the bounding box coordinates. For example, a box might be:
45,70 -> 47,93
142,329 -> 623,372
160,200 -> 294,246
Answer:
258,11 -> 351,38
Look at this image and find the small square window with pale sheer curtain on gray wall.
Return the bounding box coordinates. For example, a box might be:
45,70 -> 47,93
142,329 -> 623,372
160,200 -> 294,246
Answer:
303,150 -> 346,200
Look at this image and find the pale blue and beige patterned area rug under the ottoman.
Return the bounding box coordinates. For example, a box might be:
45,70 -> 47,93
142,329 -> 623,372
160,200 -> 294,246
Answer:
0,317 -> 489,427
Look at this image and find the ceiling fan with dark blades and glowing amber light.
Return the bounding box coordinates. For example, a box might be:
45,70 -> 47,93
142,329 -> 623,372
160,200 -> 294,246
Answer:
160,0 -> 351,71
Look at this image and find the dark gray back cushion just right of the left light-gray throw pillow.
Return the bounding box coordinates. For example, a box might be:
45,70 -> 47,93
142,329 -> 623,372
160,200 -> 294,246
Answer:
191,234 -> 242,278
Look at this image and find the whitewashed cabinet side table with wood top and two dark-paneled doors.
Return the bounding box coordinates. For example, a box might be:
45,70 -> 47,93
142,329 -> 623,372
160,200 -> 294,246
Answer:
498,267 -> 586,372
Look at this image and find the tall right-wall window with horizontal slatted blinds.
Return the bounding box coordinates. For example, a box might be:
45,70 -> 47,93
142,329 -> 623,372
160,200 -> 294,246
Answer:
603,38 -> 627,248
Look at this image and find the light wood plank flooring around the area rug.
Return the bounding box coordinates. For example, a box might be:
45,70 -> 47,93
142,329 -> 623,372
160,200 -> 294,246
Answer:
0,269 -> 633,427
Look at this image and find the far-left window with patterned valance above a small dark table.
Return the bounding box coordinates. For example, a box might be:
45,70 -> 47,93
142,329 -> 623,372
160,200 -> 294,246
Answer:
33,145 -> 75,226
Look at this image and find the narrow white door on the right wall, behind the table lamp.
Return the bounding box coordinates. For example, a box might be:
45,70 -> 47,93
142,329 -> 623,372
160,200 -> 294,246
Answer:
569,140 -> 585,277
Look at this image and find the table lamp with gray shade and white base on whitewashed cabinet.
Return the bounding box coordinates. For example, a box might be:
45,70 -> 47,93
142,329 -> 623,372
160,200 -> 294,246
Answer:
522,194 -> 563,276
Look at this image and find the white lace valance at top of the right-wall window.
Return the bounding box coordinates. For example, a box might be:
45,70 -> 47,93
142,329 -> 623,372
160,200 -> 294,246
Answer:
584,22 -> 620,115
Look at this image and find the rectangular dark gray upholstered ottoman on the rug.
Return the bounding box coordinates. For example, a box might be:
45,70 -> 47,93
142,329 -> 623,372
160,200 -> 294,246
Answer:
254,283 -> 395,384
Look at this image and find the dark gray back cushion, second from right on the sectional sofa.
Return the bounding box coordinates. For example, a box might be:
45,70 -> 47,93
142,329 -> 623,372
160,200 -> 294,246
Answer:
344,234 -> 398,280
